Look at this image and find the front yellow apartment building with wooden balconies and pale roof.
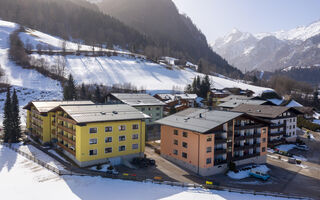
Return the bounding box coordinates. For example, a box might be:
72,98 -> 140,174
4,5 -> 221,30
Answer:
27,101 -> 148,167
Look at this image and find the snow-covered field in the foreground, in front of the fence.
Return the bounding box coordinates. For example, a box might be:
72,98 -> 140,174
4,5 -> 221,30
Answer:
0,145 -> 300,200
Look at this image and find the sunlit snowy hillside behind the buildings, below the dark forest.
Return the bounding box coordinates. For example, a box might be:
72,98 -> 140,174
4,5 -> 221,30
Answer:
10,19 -> 270,95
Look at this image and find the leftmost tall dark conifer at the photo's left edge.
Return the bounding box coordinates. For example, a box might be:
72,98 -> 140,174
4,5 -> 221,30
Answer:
3,87 -> 13,142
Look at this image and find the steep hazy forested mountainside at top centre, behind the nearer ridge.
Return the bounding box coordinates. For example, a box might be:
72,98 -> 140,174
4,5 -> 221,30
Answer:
92,0 -> 241,77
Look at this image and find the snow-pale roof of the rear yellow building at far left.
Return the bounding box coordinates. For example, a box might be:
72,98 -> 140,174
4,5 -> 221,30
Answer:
23,101 -> 94,113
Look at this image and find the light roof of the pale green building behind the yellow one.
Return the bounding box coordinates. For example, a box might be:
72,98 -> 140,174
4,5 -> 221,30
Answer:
111,93 -> 165,106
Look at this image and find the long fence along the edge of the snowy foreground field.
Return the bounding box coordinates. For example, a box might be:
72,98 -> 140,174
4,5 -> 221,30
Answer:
0,141 -> 310,199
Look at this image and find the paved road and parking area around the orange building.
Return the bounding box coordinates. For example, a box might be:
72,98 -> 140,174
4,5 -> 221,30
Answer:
119,133 -> 320,199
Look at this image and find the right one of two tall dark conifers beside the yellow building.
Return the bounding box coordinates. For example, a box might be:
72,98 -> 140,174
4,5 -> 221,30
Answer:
11,89 -> 21,143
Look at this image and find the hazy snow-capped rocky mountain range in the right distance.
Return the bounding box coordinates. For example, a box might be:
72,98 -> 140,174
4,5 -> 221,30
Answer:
212,21 -> 320,71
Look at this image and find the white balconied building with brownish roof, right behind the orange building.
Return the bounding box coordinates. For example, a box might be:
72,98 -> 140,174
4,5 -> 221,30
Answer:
232,104 -> 300,146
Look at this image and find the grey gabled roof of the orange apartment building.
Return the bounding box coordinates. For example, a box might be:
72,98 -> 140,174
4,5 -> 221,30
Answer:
156,108 -> 243,133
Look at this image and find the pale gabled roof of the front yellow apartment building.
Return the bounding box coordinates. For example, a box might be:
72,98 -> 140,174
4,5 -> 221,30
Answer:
56,104 -> 150,123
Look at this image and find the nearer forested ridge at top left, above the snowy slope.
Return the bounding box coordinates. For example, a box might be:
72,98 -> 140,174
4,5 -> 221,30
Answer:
0,0 -> 148,48
